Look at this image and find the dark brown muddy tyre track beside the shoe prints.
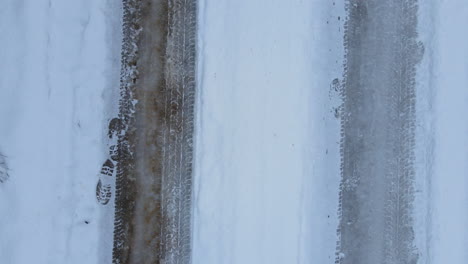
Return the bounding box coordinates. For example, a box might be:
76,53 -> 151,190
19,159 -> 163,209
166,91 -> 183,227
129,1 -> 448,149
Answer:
113,0 -> 196,263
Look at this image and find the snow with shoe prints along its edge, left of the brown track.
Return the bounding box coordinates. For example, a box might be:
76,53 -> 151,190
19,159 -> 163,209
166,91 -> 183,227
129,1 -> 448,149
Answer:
0,0 -> 122,264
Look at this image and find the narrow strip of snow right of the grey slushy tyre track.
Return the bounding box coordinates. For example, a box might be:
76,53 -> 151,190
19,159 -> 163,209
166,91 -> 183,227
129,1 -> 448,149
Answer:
422,0 -> 468,264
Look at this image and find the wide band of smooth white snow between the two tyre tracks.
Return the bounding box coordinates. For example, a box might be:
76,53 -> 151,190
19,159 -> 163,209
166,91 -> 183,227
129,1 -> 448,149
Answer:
193,0 -> 344,264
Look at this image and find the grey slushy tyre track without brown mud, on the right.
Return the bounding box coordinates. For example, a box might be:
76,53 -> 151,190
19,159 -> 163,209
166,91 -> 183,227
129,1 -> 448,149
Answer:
336,0 -> 423,264
